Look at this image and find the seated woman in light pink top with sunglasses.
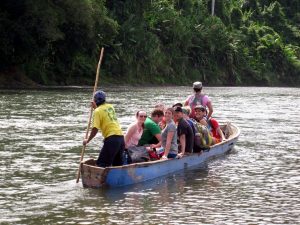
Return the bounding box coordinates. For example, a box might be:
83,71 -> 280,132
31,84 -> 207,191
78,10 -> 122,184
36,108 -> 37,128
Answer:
124,110 -> 147,149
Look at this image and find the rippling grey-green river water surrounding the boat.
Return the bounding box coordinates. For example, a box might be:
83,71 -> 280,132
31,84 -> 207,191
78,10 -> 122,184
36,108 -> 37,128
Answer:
0,87 -> 300,224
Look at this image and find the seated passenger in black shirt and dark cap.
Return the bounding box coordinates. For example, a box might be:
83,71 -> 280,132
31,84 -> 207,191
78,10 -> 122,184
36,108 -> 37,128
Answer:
174,107 -> 194,157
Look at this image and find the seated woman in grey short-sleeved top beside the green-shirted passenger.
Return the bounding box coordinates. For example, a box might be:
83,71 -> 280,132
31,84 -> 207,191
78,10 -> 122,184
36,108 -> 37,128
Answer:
152,108 -> 178,159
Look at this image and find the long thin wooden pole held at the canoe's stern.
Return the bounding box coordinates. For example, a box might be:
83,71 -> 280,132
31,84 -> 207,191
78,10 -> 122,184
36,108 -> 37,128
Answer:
76,48 -> 104,183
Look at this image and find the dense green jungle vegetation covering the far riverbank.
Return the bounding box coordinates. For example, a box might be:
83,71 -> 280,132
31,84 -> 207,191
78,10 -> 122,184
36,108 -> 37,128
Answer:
0,0 -> 300,86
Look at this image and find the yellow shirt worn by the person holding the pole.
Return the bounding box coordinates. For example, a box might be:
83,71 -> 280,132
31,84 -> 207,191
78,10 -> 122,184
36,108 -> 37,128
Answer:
93,103 -> 123,138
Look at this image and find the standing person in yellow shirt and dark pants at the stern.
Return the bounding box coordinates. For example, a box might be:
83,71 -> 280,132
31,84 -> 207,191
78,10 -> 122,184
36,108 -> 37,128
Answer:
83,91 -> 125,167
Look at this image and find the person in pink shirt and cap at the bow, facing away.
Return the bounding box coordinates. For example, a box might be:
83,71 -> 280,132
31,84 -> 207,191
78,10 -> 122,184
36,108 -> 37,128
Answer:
184,81 -> 213,119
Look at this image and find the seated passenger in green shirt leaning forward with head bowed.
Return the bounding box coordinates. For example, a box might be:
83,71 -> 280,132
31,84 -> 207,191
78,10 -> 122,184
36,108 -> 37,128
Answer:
138,109 -> 164,145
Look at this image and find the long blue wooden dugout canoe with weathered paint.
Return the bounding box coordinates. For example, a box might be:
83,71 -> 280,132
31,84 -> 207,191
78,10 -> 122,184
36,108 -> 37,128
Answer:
80,123 -> 240,188
